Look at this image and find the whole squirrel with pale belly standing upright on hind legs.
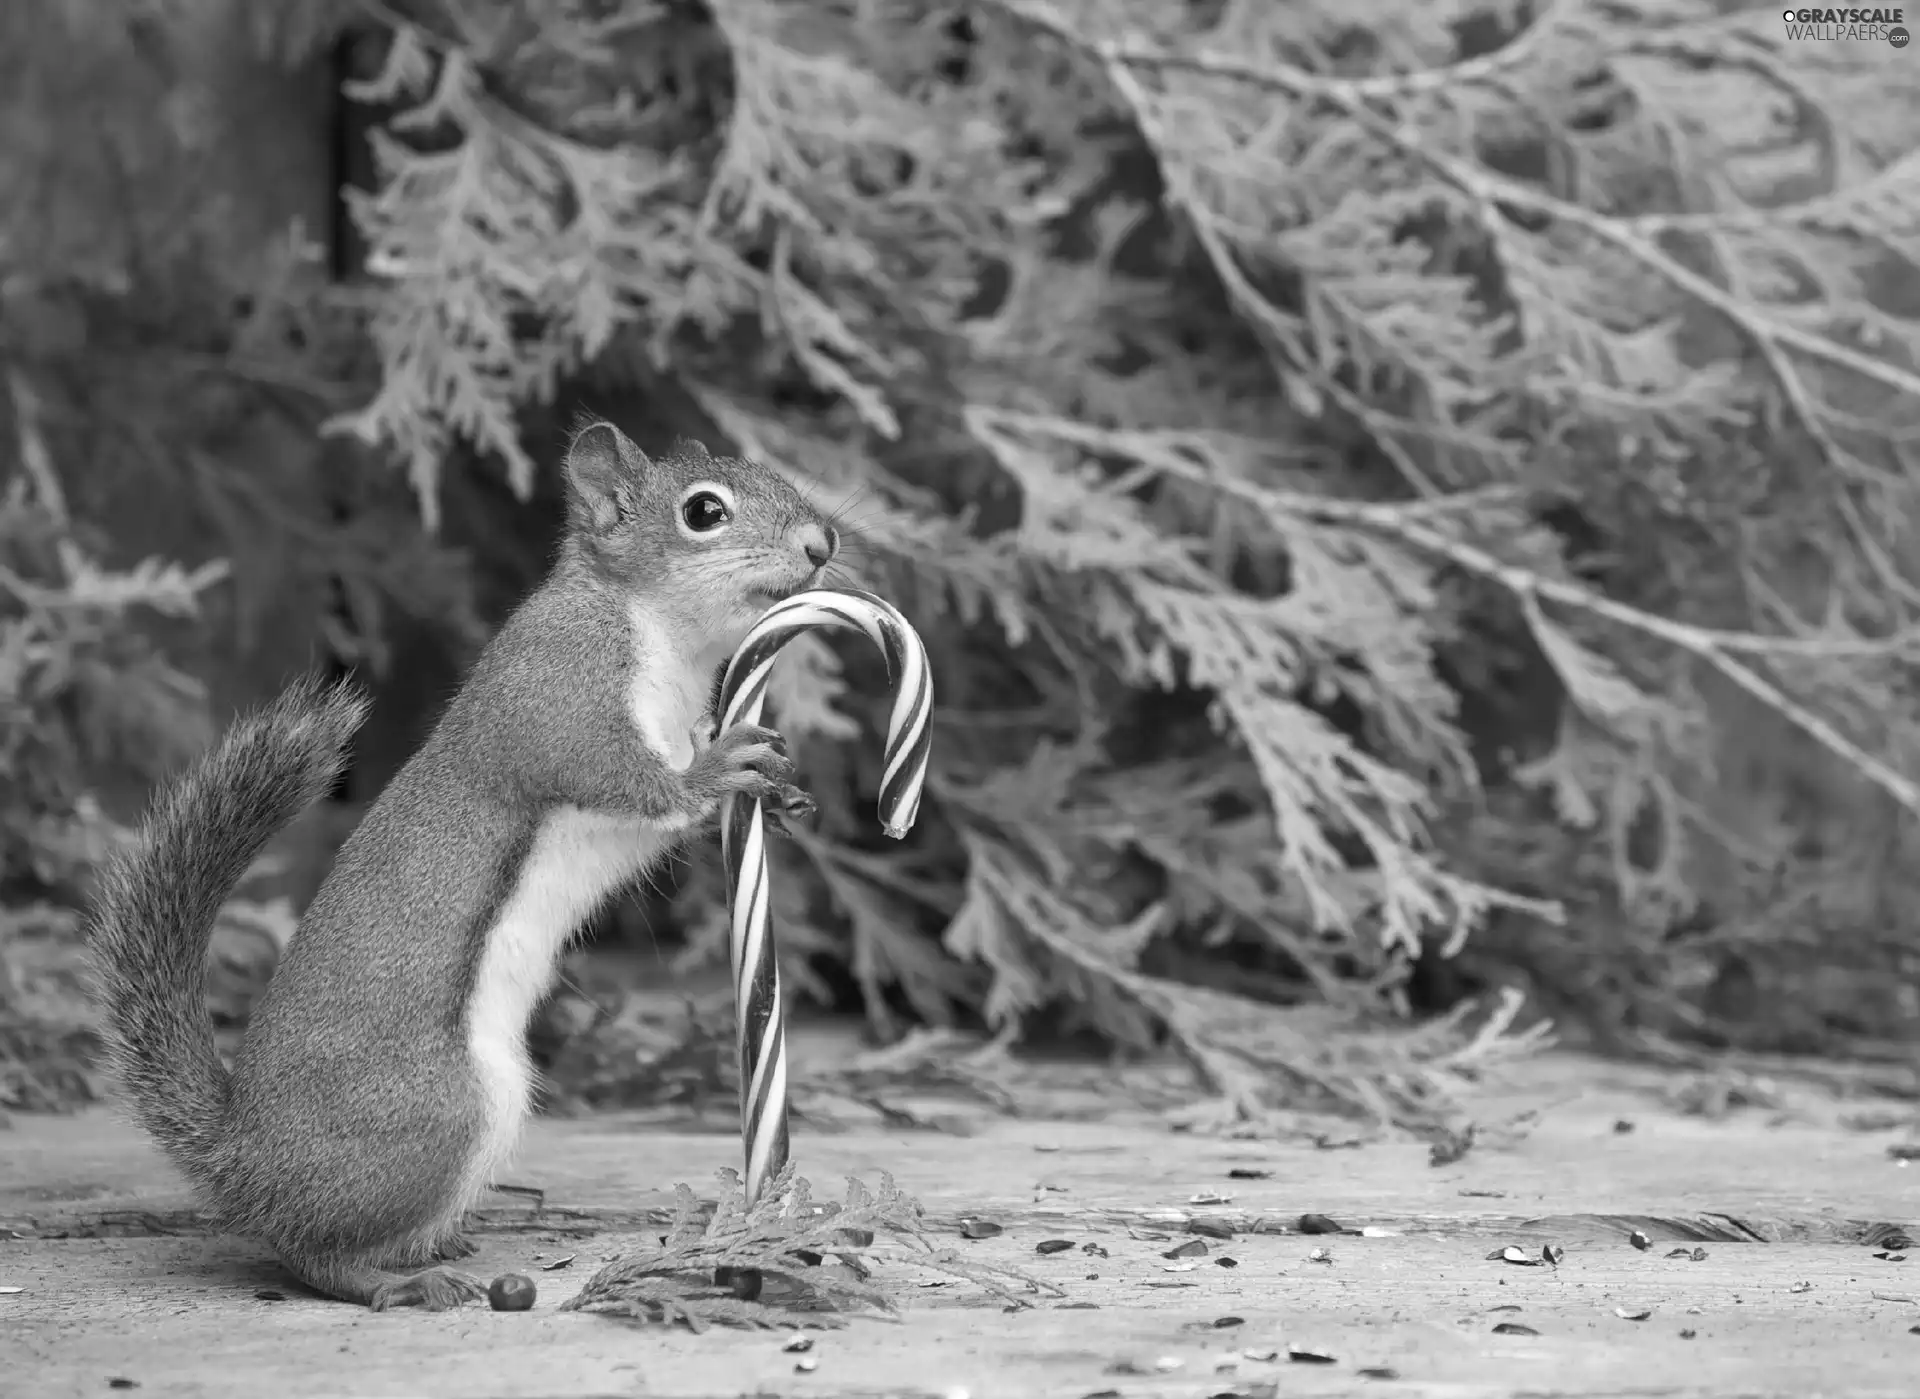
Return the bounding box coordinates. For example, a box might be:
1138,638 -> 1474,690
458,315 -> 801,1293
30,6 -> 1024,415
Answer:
88,422 -> 839,1311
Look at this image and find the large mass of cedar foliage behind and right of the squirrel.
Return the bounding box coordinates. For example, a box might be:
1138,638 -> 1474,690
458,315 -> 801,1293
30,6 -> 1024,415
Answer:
3,0 -> 1920,1121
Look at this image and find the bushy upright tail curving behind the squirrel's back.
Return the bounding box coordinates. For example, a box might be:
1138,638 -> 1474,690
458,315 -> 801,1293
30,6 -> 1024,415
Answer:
88,677 -> 367,1186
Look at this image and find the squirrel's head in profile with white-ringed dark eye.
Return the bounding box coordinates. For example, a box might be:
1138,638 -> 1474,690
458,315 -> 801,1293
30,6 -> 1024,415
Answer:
566,422 -> 839,647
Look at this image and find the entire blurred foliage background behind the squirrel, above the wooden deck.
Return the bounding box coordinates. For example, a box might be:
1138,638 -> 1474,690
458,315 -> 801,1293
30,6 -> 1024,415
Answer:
0,0 -> 1920,1125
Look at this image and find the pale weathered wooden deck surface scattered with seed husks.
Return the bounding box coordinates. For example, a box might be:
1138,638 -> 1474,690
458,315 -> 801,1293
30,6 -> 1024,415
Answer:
0,1055 -> 1920,1399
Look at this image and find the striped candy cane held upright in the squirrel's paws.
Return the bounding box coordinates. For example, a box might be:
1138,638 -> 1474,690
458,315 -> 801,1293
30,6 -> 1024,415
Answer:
720,589 -> 933,1203
